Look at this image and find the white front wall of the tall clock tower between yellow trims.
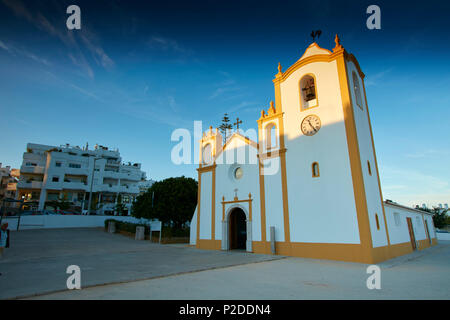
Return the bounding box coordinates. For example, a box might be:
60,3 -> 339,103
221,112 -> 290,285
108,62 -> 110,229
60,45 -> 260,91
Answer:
280,61 -> 360,243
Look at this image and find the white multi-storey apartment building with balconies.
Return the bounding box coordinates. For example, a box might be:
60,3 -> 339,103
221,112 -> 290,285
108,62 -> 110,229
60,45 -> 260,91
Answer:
16,143 -> 146,214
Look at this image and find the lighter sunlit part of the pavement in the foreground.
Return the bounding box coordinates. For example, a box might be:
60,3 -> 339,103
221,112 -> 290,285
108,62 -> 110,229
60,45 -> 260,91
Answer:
29,242 -> 450,300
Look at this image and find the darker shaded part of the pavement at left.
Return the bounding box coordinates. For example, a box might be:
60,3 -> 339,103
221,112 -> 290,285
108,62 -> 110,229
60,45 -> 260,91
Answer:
0,228 -> 282,299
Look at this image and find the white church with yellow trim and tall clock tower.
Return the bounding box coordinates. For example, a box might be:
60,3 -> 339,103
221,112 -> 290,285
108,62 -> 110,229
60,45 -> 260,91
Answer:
191,36 -> 437,264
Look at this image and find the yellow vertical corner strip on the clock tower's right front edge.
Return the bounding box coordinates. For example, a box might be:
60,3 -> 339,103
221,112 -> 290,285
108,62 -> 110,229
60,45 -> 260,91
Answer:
335,50 -> 372,261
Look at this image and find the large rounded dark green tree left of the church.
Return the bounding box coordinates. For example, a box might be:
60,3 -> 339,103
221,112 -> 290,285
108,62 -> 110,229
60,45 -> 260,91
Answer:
132,176 -> 198,229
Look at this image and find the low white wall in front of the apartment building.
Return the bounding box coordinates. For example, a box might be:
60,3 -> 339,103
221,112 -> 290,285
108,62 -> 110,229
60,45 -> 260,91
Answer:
2,215 -> 156,230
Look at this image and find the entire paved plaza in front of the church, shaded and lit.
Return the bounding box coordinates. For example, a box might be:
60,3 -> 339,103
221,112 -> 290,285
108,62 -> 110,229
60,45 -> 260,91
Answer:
0,229 -> 450,300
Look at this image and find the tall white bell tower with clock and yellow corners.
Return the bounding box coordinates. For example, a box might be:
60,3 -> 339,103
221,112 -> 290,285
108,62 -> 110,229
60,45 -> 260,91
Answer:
268,35 -> 389,261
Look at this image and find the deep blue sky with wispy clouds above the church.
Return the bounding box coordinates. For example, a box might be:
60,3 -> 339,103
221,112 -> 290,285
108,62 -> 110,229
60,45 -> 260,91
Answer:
0,0 -> 450,205
